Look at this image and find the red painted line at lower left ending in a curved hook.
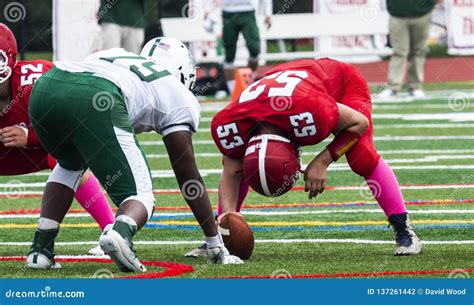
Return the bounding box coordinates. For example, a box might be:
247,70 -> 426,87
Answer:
0,256 -> 194,279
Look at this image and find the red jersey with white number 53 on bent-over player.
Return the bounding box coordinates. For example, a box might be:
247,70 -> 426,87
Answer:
211,58 -> 360,159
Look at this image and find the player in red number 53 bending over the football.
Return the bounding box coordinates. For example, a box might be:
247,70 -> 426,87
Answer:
188,58 -> 422,256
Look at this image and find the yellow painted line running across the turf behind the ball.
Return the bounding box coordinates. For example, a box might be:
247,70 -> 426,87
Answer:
0,219 -> 474,229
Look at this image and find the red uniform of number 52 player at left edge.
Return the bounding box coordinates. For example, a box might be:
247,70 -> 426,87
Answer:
0,60 -> 53,175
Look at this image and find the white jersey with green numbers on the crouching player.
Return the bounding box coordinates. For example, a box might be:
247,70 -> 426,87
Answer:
54,49 -> 201,136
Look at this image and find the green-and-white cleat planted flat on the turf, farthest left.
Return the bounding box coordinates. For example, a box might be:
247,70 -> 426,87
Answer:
26,228 -> 61,270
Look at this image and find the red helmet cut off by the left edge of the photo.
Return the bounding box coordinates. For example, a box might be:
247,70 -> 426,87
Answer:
0,23 -> 18,83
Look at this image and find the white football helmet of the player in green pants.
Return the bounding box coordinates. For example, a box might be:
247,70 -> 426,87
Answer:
140,37 -> 196,90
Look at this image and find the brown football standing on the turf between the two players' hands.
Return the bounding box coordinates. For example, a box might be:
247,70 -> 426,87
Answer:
219,213 -> 254,259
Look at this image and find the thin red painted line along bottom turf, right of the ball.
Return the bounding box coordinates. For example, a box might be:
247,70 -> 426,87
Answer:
212,269 -> 474,279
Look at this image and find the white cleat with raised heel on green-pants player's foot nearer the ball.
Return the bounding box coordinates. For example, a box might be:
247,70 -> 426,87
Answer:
99,230 -> 146,272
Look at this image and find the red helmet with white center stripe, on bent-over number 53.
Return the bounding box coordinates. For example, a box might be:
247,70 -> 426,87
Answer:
244,134 -> 300,197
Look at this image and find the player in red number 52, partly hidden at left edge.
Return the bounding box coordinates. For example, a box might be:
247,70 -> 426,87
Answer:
0,23 -> 114,255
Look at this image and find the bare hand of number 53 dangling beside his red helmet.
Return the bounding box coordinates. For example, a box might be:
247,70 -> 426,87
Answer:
304,150 -> 332,199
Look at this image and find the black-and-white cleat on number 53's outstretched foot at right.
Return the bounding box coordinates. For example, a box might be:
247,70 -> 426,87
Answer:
388,213 -> 423,256
